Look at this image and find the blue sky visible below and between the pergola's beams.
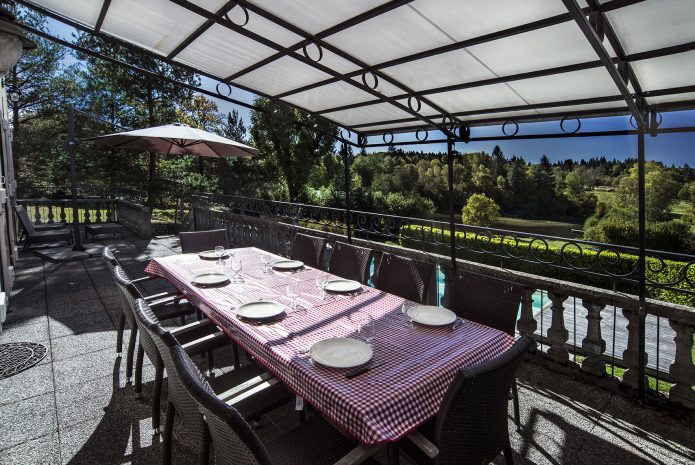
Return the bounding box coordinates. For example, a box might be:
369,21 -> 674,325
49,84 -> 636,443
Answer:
48,20 -> 695,166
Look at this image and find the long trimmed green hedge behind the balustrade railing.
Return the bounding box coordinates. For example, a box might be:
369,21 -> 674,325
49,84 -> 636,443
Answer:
400,225 -> 695,307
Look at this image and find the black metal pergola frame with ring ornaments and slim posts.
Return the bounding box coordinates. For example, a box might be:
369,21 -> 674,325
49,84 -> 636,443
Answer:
16,0 -> 695,400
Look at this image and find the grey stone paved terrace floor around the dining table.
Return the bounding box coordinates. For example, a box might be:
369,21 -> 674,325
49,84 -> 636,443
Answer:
0,237 -> 695,465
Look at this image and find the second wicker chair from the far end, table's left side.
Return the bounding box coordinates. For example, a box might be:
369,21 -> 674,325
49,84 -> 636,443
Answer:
113,265 -> 194,381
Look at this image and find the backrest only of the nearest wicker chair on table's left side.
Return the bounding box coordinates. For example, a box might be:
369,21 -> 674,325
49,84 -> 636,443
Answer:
170,346 -> 272,465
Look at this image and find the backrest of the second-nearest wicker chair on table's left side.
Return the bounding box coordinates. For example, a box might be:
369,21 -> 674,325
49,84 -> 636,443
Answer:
130,299 -> 206,435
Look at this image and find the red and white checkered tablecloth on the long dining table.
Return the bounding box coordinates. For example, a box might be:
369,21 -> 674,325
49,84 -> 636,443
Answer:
145,248 -> 514,445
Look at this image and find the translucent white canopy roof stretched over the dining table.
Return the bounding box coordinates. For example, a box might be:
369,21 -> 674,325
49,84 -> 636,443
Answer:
18,0 -> 695,136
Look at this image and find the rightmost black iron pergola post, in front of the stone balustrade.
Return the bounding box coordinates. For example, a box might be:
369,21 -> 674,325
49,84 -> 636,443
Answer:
637,123 -> 647,402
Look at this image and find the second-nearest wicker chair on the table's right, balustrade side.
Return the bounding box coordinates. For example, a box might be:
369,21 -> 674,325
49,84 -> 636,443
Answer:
372,253 -> 434,303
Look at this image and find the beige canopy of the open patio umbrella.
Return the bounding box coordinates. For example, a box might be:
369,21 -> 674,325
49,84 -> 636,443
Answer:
87,123 -> 258,158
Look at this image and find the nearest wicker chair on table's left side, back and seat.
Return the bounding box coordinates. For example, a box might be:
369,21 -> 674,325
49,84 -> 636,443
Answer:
171,340 -> 362,465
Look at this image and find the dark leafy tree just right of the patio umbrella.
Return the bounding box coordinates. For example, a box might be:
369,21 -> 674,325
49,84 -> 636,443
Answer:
251,97 -> 338,200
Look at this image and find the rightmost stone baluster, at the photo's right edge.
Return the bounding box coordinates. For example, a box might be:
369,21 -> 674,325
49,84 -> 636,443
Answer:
668,320 -> 695,409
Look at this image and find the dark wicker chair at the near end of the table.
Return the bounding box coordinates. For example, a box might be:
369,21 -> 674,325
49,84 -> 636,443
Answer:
402,336 -> 534,465
